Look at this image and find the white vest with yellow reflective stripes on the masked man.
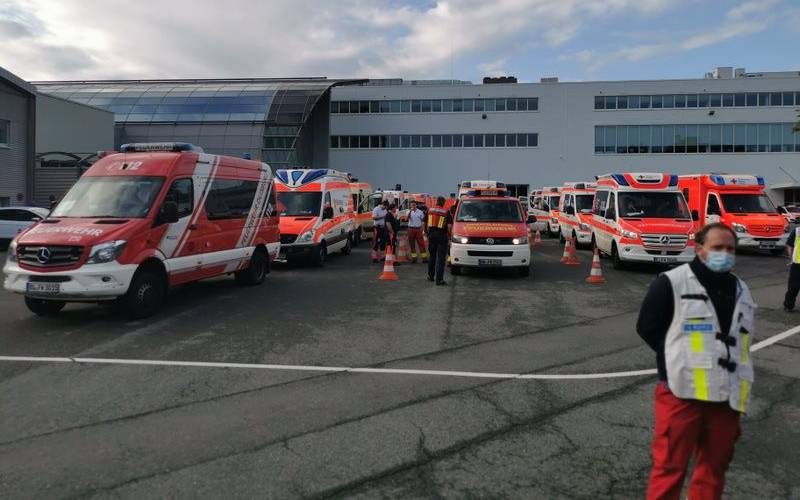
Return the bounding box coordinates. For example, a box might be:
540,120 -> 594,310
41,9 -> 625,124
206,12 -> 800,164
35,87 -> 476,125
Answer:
664,264 -> 756,412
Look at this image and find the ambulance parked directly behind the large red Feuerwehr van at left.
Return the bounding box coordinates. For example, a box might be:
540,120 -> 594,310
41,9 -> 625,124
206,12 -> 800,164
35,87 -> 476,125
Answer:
275,168 -> 356,266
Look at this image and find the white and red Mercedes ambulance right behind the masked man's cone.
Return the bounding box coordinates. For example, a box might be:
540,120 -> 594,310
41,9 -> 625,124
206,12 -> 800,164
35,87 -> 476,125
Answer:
592,173 -> 694,269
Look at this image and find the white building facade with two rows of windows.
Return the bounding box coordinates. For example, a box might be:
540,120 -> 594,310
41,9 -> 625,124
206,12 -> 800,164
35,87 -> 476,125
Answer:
330,68 -> 800,203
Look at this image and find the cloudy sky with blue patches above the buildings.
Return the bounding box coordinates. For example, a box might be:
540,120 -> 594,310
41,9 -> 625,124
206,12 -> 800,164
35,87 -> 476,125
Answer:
0,0 -> 800,81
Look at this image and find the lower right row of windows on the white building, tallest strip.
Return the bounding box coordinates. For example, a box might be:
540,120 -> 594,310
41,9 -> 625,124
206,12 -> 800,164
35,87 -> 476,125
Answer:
594,123 -> 800,154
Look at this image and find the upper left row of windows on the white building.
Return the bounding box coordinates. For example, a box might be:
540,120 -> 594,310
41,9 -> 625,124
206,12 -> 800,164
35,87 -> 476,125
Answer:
331,97 -> 539,114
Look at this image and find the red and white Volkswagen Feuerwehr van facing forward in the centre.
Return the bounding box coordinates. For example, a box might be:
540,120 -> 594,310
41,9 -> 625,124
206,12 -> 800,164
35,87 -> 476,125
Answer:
450,191 -> 535,276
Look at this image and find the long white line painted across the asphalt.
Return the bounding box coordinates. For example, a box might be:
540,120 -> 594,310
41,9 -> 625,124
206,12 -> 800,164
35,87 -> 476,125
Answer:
0,326 -> 800,380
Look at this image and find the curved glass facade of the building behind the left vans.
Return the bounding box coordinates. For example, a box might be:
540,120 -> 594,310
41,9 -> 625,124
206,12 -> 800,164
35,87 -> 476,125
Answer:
37,78 -> 347,167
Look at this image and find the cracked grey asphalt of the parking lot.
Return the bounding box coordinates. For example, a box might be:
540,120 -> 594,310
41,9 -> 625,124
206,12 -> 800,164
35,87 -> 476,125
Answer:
0,240 -> 800,499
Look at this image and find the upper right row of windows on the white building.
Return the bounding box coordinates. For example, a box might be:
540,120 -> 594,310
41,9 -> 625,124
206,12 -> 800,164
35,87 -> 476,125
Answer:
594,92 -> 800,109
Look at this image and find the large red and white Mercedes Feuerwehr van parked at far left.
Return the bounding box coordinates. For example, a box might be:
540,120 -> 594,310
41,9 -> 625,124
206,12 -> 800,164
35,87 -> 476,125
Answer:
3,143 -> 280,318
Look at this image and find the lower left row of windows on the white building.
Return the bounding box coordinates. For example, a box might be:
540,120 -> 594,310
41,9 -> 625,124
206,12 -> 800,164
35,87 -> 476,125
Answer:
331,134 -> 539,149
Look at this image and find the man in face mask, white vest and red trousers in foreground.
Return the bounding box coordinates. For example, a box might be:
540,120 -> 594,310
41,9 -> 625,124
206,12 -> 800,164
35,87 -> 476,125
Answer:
636,223 -> 756,499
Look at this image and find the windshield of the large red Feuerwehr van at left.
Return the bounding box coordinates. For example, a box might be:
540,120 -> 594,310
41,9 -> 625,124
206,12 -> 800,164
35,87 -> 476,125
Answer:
50,175 -> 164,219
